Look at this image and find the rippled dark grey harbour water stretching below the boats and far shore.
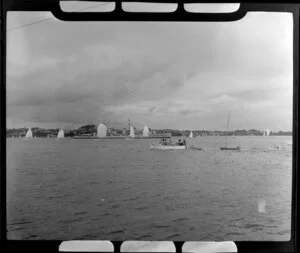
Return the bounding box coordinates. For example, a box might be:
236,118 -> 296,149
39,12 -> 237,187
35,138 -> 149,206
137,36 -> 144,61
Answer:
7,136 -> 292,241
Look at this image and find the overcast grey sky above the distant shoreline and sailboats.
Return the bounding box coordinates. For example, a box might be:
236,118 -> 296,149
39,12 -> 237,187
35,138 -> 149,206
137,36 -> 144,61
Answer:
7,3 -> 293,131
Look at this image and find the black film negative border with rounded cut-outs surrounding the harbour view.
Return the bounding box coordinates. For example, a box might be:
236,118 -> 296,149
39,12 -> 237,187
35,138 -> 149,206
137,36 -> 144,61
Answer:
0,0 -> 300,253
